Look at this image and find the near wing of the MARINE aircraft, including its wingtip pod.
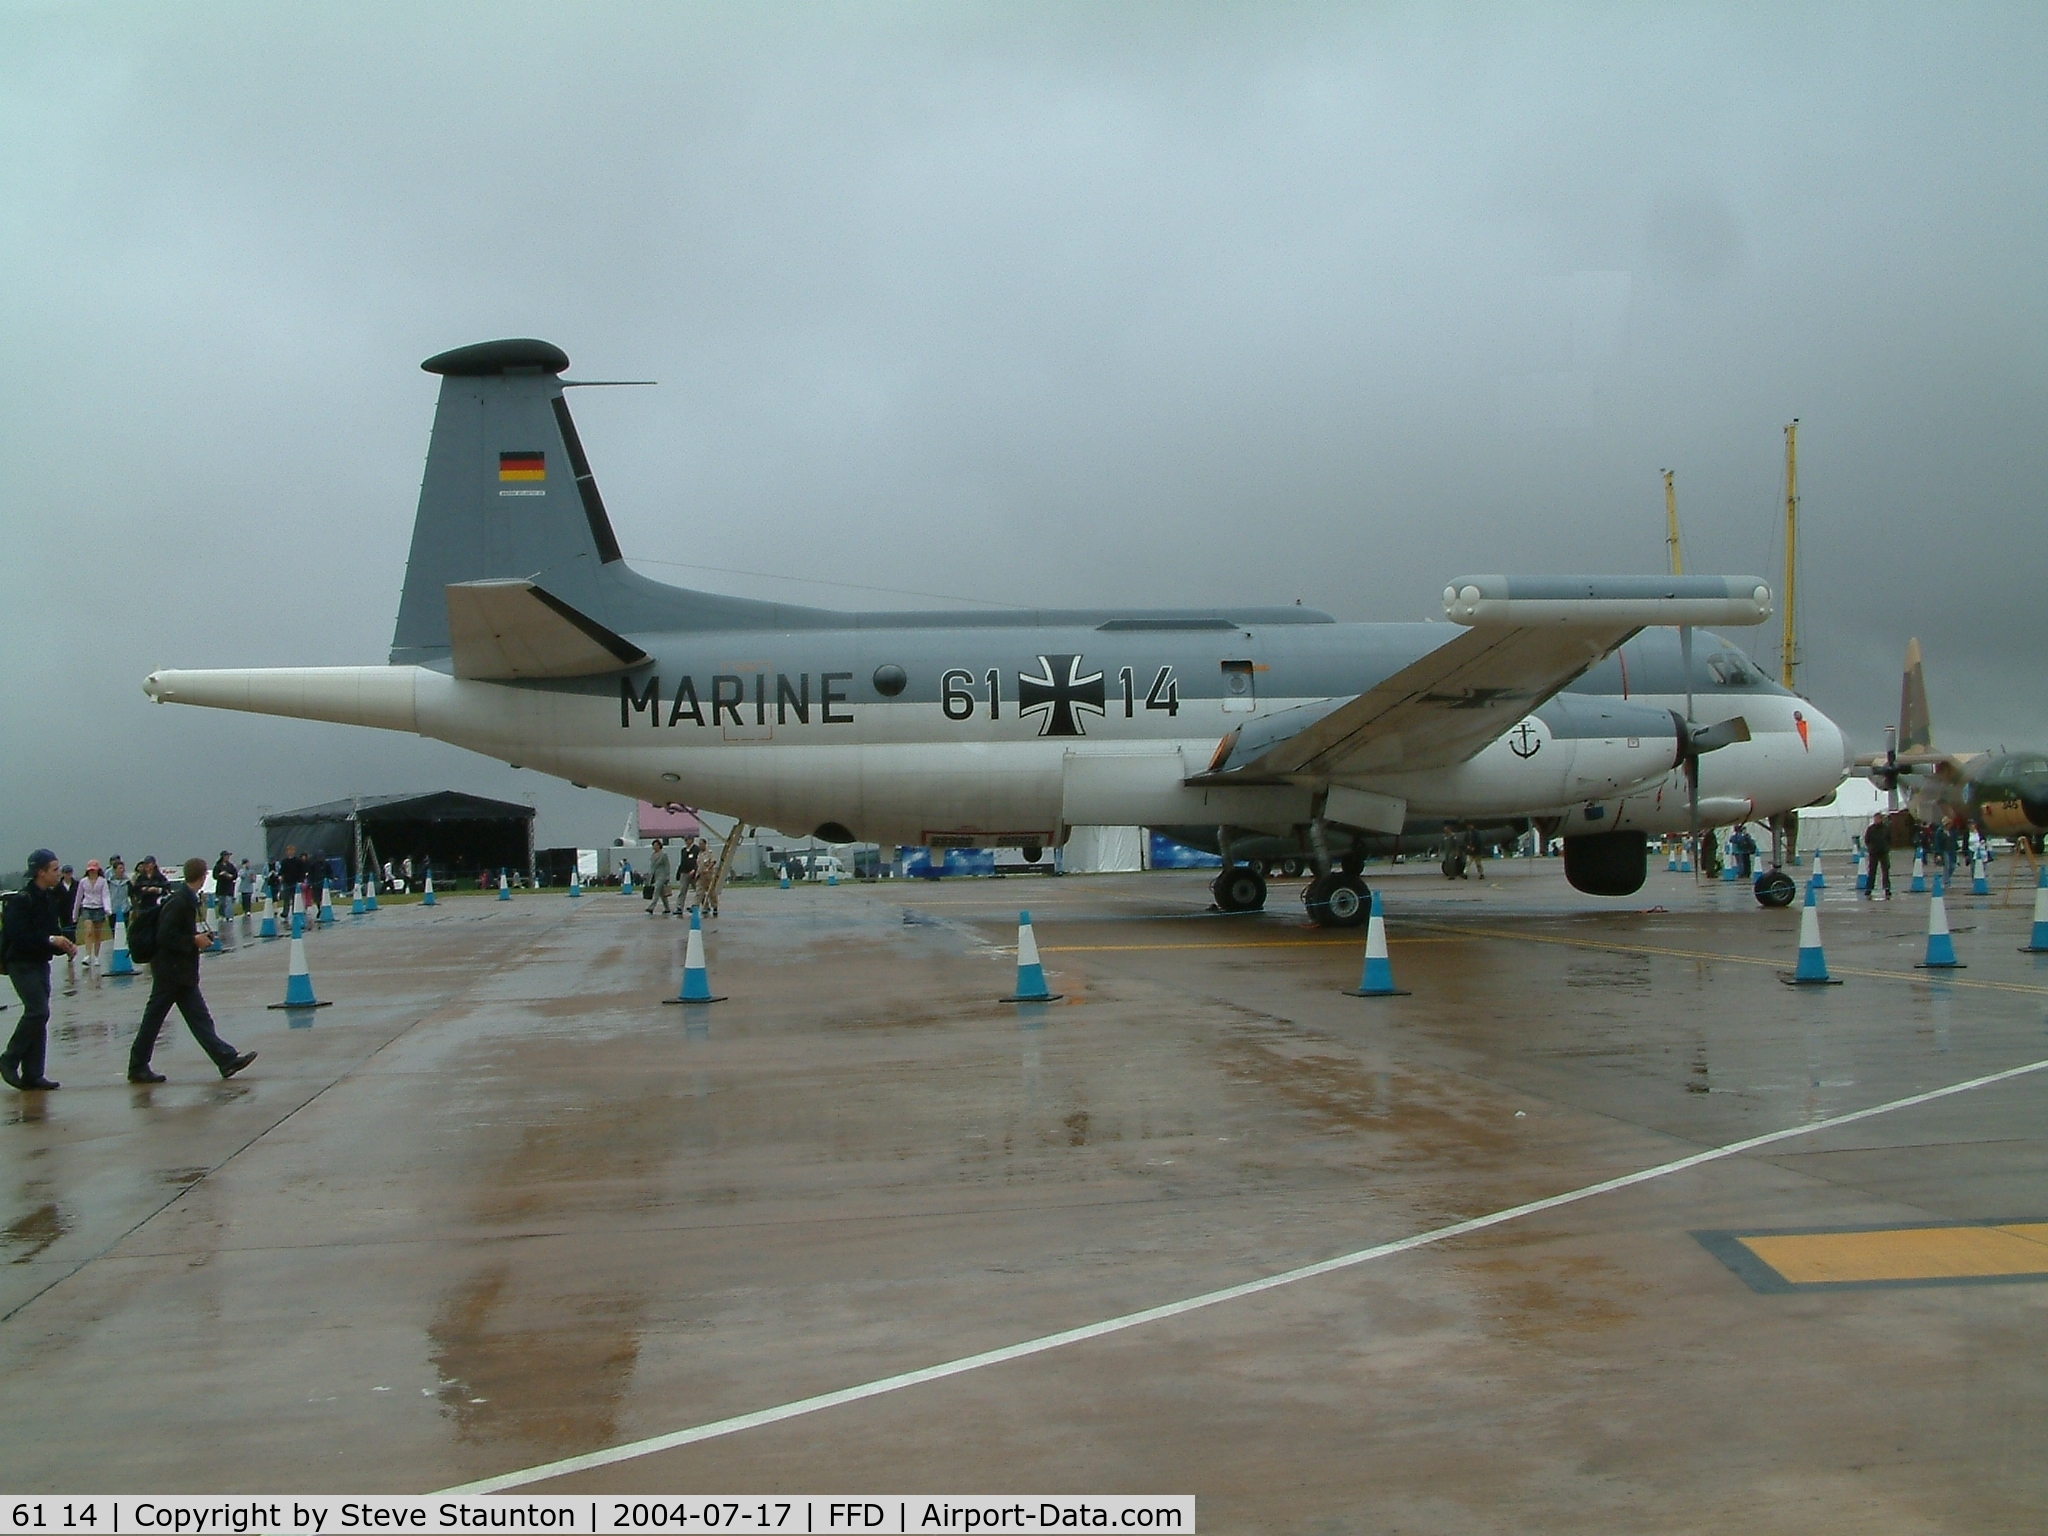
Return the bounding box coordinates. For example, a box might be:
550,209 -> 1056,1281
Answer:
1194,575 -> 1772,784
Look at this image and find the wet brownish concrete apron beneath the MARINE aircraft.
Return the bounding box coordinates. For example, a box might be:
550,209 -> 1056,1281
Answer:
0,862 -> 2048,1532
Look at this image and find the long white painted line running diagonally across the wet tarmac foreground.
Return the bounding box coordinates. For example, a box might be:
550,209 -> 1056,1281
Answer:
442,1059 -> 2048,1493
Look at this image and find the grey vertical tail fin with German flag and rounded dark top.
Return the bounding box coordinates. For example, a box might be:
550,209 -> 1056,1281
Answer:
391,340 -> 621,664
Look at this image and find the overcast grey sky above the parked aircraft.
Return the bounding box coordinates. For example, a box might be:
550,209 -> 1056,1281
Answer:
0,4 -> 2048,862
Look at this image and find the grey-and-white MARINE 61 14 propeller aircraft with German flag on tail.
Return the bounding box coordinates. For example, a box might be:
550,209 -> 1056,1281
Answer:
145,340 -> 1845,926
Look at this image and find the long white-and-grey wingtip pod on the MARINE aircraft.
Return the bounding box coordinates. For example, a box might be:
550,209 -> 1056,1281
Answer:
1444,575 -> 1772,627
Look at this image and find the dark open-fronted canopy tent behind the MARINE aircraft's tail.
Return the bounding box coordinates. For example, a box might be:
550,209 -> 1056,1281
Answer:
262,788 -> 532,879
